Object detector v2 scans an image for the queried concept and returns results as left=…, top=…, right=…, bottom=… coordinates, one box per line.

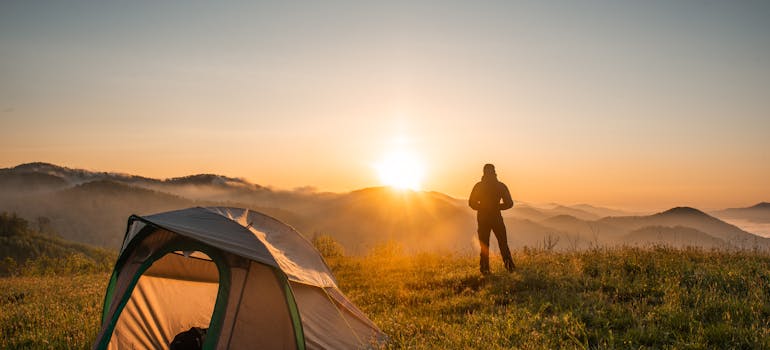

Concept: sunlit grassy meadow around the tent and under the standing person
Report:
left=0, top=248, right=770, bottom=349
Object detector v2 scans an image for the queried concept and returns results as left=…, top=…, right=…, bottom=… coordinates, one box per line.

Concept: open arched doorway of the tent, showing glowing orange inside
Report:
left=109, top=251, right=220, bottom=349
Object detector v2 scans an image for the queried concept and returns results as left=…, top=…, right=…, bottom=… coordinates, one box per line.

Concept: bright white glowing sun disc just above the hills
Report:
left=374, top=151, right=425, bottom=191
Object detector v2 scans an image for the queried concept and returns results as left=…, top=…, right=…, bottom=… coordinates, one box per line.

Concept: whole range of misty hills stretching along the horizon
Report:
left=0, top=163, right=770, bottom=254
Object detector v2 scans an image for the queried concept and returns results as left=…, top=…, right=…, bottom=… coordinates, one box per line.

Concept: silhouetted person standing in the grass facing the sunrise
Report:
left=468, top=164, right=515, bottom=274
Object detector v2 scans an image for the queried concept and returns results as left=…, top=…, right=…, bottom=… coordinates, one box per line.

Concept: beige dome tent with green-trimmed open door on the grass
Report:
left=94, top=207, right=385, bottom=349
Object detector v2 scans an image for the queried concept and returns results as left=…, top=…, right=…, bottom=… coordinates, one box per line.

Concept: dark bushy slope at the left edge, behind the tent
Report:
left=0, top=212, right=116, bottom=276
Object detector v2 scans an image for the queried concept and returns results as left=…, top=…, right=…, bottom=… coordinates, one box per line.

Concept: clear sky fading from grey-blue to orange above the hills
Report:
left=0, top=0, right=770, bottom=209
